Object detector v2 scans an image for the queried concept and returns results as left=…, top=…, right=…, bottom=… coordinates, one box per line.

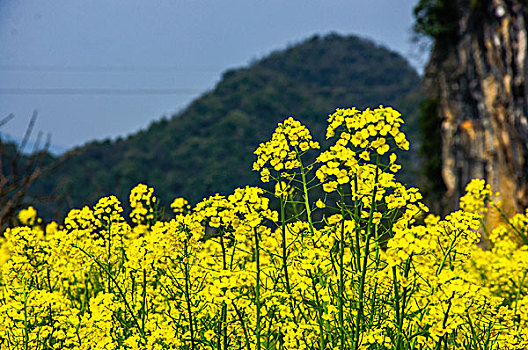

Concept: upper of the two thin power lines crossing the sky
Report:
left=0, top=65, right=224, bottom=73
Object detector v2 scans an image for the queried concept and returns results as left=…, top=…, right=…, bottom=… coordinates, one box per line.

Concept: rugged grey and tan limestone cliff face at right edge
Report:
left=424, top=0, right=528, bottom=213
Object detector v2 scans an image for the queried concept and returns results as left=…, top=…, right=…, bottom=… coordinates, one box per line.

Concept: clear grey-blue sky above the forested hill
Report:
left=0, top=0, right=426, bottom=150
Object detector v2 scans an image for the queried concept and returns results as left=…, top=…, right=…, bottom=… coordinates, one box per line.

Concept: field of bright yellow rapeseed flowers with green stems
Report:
left=0, top=106, right=528, bottom=350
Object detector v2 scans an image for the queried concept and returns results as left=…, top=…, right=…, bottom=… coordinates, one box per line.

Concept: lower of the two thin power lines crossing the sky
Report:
left=0, top=88, right=204, bottom=96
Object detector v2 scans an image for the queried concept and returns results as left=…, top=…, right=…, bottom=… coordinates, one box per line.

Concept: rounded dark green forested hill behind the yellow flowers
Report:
left=34, top=34, right=420, bottom=216
